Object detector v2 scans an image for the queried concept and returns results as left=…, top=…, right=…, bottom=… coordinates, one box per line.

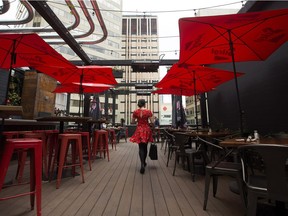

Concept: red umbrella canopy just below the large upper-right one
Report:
left=156, top=64, right=243, bottom=92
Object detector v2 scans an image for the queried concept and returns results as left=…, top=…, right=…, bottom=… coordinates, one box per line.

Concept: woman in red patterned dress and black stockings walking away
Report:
left=130, top=99, right=154, bottom=174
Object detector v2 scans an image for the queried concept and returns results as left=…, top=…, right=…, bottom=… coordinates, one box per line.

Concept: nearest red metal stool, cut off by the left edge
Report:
left=0, top=138, right=42, bottom=216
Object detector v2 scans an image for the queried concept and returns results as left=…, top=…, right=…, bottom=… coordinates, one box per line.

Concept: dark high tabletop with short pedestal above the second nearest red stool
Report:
left=36, top=116, right=91, bottom=133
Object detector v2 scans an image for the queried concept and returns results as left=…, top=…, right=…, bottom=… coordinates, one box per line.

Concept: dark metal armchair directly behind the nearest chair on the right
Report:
left=198, top=137, right=246, bottom=210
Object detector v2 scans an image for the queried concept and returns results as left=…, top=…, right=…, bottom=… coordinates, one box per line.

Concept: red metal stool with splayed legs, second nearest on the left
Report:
left=50, top=134, right=85, bottom=189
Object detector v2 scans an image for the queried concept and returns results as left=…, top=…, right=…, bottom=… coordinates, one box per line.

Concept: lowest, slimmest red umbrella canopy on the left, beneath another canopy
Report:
left=53, top=83, right=114, bottom=94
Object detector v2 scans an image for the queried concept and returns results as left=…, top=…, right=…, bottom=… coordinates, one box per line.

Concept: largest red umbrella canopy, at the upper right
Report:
left=179, top=9, right=288, bottom=65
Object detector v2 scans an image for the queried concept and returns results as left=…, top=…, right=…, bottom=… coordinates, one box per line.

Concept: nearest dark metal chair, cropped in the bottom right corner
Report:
left=239, top=144, right=288, bottom=216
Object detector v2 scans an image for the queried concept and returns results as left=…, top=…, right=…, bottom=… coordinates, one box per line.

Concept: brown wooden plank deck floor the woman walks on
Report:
left=0, top=140, right=244, bottom=216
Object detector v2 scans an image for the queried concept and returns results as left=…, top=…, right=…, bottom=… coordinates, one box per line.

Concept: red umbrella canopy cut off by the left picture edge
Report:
left=0, top=33, right=75, bottom=69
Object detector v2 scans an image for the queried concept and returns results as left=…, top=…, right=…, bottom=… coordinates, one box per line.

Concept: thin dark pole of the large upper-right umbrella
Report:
left=228, top=30, right=243, bottom=134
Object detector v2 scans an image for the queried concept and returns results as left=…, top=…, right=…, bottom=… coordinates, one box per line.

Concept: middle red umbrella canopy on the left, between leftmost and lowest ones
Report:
left=36, top=65, right=117, bottom=85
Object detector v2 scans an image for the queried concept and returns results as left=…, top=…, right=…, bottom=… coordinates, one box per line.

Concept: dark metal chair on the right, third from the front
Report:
left=173, top=133, right=206, bottom=182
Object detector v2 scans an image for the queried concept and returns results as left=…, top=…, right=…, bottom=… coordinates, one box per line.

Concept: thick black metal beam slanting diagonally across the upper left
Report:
left=28, top=0, right=92, bottom=65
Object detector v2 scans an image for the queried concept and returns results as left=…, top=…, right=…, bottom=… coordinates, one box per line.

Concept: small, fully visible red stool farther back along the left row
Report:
left=92, top=130, right=110, bottom=161
